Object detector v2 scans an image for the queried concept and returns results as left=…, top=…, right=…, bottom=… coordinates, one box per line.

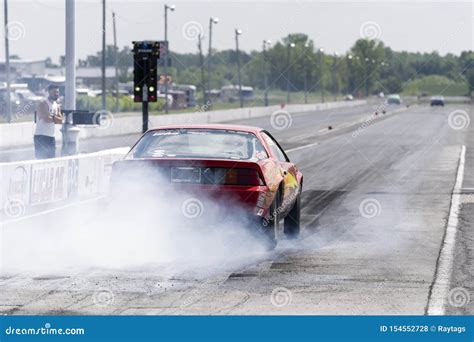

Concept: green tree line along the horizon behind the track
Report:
left=79, top=33, right=474, bottom=96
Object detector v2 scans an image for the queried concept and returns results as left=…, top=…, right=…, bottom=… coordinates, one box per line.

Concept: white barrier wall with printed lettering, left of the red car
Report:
left=0, top=147, right=129, bottom=219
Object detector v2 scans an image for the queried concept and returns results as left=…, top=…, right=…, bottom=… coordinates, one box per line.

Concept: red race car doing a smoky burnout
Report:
left=112, top=124, right=303, bottom=249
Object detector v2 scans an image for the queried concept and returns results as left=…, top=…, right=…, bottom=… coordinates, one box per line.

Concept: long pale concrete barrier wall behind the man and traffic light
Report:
left=0, top=100, right=367, bottom=148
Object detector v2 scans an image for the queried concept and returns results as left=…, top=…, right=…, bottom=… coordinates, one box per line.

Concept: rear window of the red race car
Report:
left=128, top=129, right=268, bottom=160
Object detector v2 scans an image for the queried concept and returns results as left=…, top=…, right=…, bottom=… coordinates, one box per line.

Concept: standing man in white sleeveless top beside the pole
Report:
left=34, top=84, right=63, bottom=159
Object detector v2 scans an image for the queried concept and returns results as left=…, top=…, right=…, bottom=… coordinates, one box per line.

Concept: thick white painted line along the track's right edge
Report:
left=426, top=145, right=466, bottom=315
